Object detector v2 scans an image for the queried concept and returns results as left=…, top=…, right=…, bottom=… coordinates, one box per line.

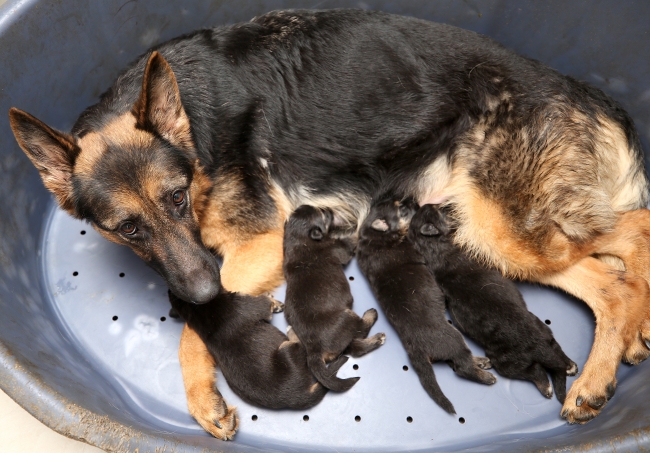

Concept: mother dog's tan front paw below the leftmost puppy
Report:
left=188, top=388, right=239, bottom=440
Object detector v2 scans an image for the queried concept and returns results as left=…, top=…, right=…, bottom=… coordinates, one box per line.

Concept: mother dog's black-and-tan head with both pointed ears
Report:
left=9, top=52, right=220, bottom=303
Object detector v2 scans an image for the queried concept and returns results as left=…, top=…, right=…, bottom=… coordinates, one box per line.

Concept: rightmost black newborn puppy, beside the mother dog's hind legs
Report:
left=409, top=205, right=578, bottom=403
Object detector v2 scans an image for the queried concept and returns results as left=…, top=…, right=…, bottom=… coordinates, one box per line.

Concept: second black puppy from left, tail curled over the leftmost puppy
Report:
left=283, top=205, right=386, bottom=392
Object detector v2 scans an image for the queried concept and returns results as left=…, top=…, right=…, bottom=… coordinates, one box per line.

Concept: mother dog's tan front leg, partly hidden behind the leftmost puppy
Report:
left=179, top=230, right=282, bottom=440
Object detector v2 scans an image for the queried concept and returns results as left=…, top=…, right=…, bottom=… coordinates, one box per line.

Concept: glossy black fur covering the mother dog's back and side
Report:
left=72, top=9, right=643, bottom=228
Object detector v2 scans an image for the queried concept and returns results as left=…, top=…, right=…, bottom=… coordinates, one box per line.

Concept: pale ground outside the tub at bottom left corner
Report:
left=0, top=386, right=104, bottom=453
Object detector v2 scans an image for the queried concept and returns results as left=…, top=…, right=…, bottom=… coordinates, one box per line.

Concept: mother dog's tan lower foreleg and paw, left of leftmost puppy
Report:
left=178, top=325, right=239, bottom=440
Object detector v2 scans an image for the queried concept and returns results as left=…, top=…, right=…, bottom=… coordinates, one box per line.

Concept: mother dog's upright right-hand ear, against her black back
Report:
left=133, top=51, right=194, bottom=151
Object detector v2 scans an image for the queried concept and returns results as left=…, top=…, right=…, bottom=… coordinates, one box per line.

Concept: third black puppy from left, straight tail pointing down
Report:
left=357, top=200, right=496, bottom=414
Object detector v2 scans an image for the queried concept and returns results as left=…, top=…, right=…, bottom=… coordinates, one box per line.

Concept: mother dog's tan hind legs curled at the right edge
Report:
left=537, top=257, right=650, bottom=423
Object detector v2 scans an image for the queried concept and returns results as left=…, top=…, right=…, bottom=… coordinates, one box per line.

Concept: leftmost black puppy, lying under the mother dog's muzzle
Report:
left=169, top=288, right=347, bottom=409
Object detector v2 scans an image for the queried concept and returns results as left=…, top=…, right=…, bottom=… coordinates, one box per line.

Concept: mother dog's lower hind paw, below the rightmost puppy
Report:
left=560, top=376, right=616, bottom=424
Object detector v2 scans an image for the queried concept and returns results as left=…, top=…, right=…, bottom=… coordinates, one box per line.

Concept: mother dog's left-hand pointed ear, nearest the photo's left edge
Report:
left=9, top=107, right=79, bottom=217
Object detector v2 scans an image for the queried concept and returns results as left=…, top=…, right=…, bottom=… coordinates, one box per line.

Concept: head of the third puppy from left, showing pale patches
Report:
left=359, top=198, right=418, bottom=237
